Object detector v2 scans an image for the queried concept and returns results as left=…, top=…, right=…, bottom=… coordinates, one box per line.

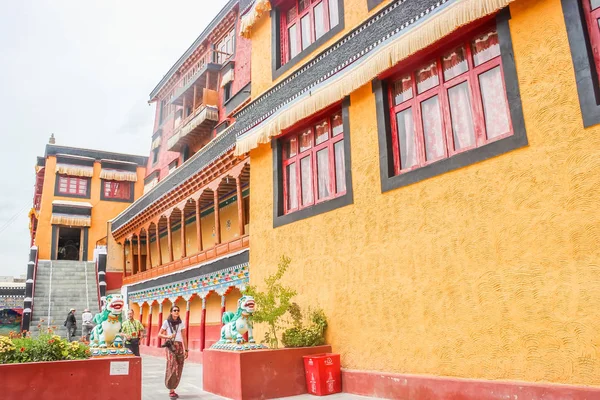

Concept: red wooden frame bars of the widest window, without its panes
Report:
left=388, top=24, right=514, bottom=175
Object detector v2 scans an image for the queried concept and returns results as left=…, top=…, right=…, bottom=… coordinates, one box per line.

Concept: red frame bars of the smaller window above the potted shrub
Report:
left=280, top=110, right=347, bottom=214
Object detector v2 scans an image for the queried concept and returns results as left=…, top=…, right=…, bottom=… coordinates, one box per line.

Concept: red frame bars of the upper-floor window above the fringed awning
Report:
left=280, top=0, right=340, bottom=65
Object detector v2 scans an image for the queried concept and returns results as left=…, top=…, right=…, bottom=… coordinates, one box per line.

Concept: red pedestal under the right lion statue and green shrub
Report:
left=202, top=346, right=331, bottom=400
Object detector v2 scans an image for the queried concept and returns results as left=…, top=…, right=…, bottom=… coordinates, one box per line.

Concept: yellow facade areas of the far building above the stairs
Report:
left=35, top=156, right=146, bottom=262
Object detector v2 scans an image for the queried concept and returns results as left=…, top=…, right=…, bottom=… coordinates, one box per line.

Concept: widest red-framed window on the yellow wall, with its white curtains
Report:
left=389, top=27, right=510, bottom=174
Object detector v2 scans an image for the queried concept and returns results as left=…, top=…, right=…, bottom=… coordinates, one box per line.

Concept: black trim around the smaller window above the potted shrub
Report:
left=271, top=97, right=354, bottom=228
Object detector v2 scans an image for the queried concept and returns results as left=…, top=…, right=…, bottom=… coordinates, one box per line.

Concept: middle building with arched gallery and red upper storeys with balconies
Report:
left=108, top=0, right=251, bottom=358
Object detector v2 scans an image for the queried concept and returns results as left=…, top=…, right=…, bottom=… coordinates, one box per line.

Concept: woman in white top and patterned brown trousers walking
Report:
left=158, top=305, right=188, bottom=399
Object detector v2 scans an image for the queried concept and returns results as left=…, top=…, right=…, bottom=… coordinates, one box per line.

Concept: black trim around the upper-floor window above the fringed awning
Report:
left=271, top=0, right=345, bottom=80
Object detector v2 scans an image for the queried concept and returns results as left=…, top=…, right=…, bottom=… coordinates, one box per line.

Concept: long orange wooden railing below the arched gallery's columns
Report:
left=123, top=235, right=250, bottom=285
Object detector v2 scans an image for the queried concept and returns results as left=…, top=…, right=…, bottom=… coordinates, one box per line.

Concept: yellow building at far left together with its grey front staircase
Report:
left=23, top=137, right=147, bottom=334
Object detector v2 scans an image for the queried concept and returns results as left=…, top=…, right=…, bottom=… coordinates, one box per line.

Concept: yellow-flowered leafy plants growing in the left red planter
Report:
left=0, top=329, right=91, bottom=364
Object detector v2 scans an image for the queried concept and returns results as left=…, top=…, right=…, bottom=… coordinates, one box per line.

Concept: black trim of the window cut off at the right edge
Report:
left=561, top=0, right=600, bottom=128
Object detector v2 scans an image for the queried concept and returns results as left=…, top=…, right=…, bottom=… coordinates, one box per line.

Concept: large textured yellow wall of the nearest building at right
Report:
left=250, top=0, right=600, bottom=385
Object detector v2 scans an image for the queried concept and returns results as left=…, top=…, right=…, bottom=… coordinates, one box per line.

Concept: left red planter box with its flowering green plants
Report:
left=0, top=325, right=142, bottom=400
